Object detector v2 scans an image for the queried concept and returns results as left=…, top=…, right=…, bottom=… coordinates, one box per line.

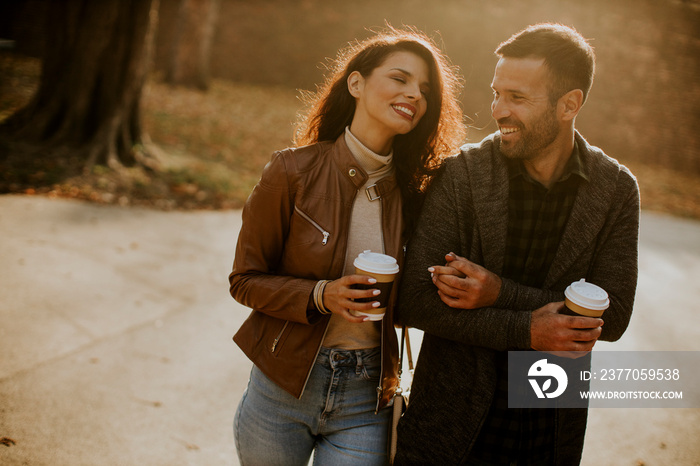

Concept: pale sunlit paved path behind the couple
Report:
left=0, top=195, right=700, bottom=466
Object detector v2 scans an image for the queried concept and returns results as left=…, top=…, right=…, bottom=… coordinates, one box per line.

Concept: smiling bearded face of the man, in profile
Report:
left=491, top=58, right=560, bottom=160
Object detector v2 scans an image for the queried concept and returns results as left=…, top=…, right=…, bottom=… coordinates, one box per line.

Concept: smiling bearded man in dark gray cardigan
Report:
left=396, top=24, right=639, bottom=466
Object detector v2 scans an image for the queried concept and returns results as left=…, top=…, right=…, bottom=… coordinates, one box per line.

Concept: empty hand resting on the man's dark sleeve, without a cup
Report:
left=428, top=253, right=501, bottom=309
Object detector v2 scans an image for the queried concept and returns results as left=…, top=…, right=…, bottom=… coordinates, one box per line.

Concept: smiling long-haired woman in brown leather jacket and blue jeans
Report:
left=229, top=29, right=464, bottom=466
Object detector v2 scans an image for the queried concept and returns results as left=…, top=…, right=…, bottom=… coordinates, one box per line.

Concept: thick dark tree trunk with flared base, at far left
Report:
left=2, top=0, right=158, bottom=173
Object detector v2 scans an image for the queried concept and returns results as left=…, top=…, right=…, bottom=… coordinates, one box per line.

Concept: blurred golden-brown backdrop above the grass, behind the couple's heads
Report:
left=155, top=0, right=700, bottom=174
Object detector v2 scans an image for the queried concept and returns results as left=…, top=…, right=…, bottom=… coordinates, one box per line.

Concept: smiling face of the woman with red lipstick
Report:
left=348, top=51, right=430, bottom=154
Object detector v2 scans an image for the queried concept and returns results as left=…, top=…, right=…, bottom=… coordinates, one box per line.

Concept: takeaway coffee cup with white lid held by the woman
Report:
left=350, top=250, right=399, bottom=320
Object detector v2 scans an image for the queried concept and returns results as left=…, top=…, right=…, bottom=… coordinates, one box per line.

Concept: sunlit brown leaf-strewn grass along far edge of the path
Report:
left=0, top=55, right=700, bottom=219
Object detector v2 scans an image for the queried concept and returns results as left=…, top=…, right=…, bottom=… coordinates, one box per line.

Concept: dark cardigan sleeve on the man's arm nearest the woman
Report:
left=398, top=157, right=530, bottom=350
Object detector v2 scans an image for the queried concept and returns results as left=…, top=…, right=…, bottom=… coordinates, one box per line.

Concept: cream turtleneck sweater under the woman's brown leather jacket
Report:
left=323, top=127, right=393, bottom=349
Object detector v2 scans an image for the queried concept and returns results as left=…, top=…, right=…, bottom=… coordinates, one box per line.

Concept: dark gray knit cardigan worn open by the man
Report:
left=397, top=133, right=639, bottom=465
